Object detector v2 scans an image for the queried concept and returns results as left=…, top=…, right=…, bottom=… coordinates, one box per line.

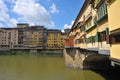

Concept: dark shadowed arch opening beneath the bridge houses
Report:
left=83, top=54, right=110, bottom=69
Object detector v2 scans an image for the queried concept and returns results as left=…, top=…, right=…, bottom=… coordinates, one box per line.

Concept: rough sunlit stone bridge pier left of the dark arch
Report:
left=64, top=48, right=85, bottom=69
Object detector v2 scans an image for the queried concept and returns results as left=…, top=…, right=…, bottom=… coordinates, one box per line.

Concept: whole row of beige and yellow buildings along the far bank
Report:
left=0, top=23, right=64, bottom=50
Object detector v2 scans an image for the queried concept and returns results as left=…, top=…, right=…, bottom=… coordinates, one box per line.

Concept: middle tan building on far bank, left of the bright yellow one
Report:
left=23, top=26, right=45, bottom=49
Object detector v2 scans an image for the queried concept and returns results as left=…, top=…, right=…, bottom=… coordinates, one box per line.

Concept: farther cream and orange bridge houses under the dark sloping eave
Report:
left=72, top=0, right=98, bottom=51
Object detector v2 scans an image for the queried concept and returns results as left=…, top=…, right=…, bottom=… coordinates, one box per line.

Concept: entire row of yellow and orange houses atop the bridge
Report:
left=65, top=0, right=120, bottom=66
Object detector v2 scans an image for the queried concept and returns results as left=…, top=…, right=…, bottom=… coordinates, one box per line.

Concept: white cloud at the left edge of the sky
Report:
left=0, top=0, right=18, bottom=27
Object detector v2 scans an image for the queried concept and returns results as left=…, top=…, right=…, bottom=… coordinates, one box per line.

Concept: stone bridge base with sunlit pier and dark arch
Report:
left=64, top=47, right=110, bottom=69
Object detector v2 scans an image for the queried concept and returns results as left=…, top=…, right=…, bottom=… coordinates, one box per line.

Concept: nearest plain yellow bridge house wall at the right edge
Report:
left=108, top=0, right=120, bottom=66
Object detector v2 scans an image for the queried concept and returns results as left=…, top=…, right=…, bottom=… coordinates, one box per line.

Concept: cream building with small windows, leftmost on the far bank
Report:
left=0, top=28, right=18, bottom=48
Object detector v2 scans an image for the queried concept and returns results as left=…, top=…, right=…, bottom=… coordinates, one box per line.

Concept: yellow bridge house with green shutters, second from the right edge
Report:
left=92, top=0, right=110, bottom=55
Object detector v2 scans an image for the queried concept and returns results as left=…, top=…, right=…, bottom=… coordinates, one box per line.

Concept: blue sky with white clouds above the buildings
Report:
left=0, top=0, right=84, bottom=31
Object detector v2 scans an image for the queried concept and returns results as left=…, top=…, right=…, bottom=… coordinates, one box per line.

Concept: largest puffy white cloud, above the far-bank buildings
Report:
left=13, top=0, right=54, bottom=26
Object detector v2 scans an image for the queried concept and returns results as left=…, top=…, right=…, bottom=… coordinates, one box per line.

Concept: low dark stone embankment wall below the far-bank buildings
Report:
left=0, top=48, right=63, bottom=56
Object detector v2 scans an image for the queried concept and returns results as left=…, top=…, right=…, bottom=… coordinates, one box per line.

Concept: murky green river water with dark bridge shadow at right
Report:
left=0, top=55, right=120, bottom=80
